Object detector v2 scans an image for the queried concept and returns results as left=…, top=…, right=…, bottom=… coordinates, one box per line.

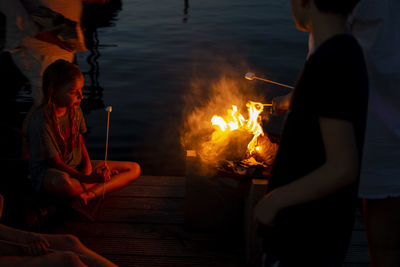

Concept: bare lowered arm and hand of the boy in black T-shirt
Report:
left=255, top=117, right=359, bottom=225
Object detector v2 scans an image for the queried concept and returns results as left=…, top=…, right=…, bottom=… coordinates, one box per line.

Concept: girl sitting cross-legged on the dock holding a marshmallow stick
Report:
left=28, top=60, right=140, bottom=211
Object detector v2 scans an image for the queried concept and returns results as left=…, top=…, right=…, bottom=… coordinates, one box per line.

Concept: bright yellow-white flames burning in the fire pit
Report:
left=211, top=101, right=264, bottom=158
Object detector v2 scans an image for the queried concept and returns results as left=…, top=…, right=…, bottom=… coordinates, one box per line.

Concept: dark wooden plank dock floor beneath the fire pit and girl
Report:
left=44, top=176, right=369, bottom=267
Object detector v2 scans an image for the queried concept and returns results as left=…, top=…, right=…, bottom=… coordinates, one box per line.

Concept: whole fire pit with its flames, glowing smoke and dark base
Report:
left=181, top=76, right=279, bottom=264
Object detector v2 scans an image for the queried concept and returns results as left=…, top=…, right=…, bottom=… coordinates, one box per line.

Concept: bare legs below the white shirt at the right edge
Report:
left=364, top=198, right=400, bottom=267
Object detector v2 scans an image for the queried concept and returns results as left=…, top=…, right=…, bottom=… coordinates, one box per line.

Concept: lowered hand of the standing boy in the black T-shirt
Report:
left=254, top=190, right=281, bottom=226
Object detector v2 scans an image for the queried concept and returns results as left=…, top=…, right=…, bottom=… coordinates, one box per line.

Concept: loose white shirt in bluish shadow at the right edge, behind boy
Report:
left=350, top=0, right=400, bottom=199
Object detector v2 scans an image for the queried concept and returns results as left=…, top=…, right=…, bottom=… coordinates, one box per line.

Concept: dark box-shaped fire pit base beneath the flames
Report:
left=184, top=150, right=276, bottom=266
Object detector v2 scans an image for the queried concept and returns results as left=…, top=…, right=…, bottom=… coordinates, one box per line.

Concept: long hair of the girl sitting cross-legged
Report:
left=41, top=59, right=83, bottom=156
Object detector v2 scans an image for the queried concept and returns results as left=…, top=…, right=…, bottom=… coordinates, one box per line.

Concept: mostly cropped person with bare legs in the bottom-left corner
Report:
left=0, top=195, right=116, bottom=267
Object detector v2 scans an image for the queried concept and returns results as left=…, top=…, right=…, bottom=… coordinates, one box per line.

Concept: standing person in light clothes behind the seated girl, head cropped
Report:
left=0, top=0, right=106, bottom=158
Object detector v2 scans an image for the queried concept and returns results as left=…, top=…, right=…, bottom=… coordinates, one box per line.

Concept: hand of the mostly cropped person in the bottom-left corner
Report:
left=18, top=232, right=50, bottom=256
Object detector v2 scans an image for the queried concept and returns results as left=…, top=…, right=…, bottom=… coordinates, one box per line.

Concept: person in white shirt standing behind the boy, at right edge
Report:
left=350, top=0, right=400, bottom=267
